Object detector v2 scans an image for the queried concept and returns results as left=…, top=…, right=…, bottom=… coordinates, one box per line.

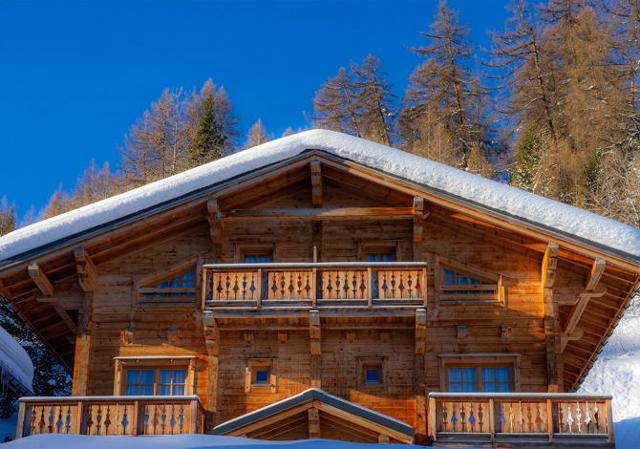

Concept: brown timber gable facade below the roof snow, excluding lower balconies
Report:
left=0, top=140, right=639, bottom=442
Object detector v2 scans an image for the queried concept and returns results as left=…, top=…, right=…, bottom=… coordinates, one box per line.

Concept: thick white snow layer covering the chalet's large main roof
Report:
left=0, top=130, right=640, bottom=264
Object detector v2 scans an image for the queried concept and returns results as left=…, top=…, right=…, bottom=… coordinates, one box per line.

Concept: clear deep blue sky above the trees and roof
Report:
left=0, top=0, right=507, bottom=221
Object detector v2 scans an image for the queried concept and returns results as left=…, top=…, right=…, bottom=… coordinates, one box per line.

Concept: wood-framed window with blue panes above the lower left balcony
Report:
left=113, top=356, right=195, bottom=396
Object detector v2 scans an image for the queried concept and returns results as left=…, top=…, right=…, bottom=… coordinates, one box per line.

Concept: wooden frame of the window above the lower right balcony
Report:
left=439, top=354, right=520, bottom=392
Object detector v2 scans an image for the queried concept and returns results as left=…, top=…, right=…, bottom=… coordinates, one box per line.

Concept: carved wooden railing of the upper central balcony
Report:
left=203, top=262, right=427, bottom=307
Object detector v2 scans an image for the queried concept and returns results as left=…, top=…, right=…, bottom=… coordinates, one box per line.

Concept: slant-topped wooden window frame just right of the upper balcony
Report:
left=434, top=258, right=507, bottom=305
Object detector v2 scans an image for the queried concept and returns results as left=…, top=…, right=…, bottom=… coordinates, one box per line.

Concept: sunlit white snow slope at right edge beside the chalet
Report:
left=580, top=300, right=640, bottom=449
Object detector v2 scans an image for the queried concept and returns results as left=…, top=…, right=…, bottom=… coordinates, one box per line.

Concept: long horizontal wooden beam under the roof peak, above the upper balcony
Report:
left=223, top=207, right=414, bottom=221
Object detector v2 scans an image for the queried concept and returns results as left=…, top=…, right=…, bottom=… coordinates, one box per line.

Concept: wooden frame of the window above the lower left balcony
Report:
left=113, top=356, right=196, bottom=396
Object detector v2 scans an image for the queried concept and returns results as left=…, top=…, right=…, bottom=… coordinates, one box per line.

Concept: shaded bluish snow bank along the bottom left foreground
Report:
left=2, top=435, right=415, bottom=449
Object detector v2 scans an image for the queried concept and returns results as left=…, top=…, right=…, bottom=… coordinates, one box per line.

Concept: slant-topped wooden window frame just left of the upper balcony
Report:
left=133, top=257, right=203, bottom=307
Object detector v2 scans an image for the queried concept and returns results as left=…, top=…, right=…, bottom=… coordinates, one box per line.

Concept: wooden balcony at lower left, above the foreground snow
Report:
left=16, top=396, right=204, bottom=438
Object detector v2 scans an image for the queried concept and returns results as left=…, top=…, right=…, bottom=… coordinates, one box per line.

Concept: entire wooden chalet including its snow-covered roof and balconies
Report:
left=0, top=130, right=640, bottom=447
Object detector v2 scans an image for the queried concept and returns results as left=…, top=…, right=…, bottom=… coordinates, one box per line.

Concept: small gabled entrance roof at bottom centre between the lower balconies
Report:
left=213, top=388, right=413, bottom=444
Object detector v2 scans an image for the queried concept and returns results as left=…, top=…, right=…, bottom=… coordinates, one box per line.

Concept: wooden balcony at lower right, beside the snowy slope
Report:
left=428, top=393, right=614, bottom=448
